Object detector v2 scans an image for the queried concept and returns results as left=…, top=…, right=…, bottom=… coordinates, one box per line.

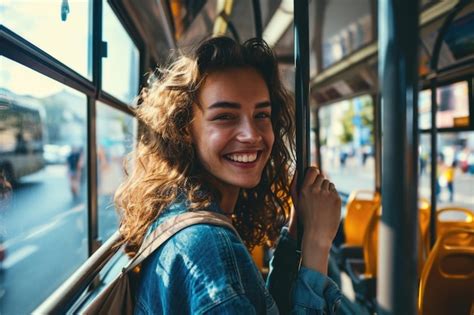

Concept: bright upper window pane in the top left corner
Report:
left=0, top=0, right=92, bottom=79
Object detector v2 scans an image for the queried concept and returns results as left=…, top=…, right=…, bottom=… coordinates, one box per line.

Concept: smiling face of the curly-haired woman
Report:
left=191, top=68, right=274, bottom=193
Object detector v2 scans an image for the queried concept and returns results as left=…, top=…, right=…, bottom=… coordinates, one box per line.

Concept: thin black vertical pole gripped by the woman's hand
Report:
left=293, top=0, right=310, bottom=250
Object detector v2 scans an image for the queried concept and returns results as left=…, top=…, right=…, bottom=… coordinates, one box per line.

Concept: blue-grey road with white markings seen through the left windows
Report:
left=0, top=165, right=116, bottom=315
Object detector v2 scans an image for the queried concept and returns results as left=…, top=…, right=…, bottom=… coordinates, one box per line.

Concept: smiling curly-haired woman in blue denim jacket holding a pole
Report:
left=116, top=37, right=341, bottom=314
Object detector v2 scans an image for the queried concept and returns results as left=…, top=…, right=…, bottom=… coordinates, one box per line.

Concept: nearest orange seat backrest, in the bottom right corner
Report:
left=418, top=229, right=474, bottom=315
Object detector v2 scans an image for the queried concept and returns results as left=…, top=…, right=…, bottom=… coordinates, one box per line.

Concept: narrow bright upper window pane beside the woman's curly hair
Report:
left=102, top=1, right=140, bottom=103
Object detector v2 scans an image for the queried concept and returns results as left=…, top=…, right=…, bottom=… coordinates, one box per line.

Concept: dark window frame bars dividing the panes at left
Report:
left=0, top=0, right=143, bottom=256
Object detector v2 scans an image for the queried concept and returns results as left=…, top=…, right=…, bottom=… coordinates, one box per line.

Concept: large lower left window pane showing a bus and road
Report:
left=0, top=57, right=88, bottom=314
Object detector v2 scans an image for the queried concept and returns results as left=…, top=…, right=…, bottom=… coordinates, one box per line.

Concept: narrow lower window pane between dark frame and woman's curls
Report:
left=97, top=102, right=137, bottom=241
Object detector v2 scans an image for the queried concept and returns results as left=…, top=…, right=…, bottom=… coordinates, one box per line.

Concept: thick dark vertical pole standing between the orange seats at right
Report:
left=377, top=0, right=419, bottom=315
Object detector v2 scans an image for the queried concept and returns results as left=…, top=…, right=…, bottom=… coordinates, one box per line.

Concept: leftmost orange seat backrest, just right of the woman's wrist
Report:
left=344, top=190, right=380, bottom=246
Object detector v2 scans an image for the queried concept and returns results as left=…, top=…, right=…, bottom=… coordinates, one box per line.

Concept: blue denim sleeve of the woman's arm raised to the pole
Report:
left=267, top=228, right=341, bottom=314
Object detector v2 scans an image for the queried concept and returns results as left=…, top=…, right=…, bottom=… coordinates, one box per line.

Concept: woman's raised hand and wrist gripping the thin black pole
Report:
left=289, top=167, right=341, bottom=274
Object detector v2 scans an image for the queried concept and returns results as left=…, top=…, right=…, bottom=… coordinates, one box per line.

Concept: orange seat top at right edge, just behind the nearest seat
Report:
left=436, top=207, right=474, bottom=245
